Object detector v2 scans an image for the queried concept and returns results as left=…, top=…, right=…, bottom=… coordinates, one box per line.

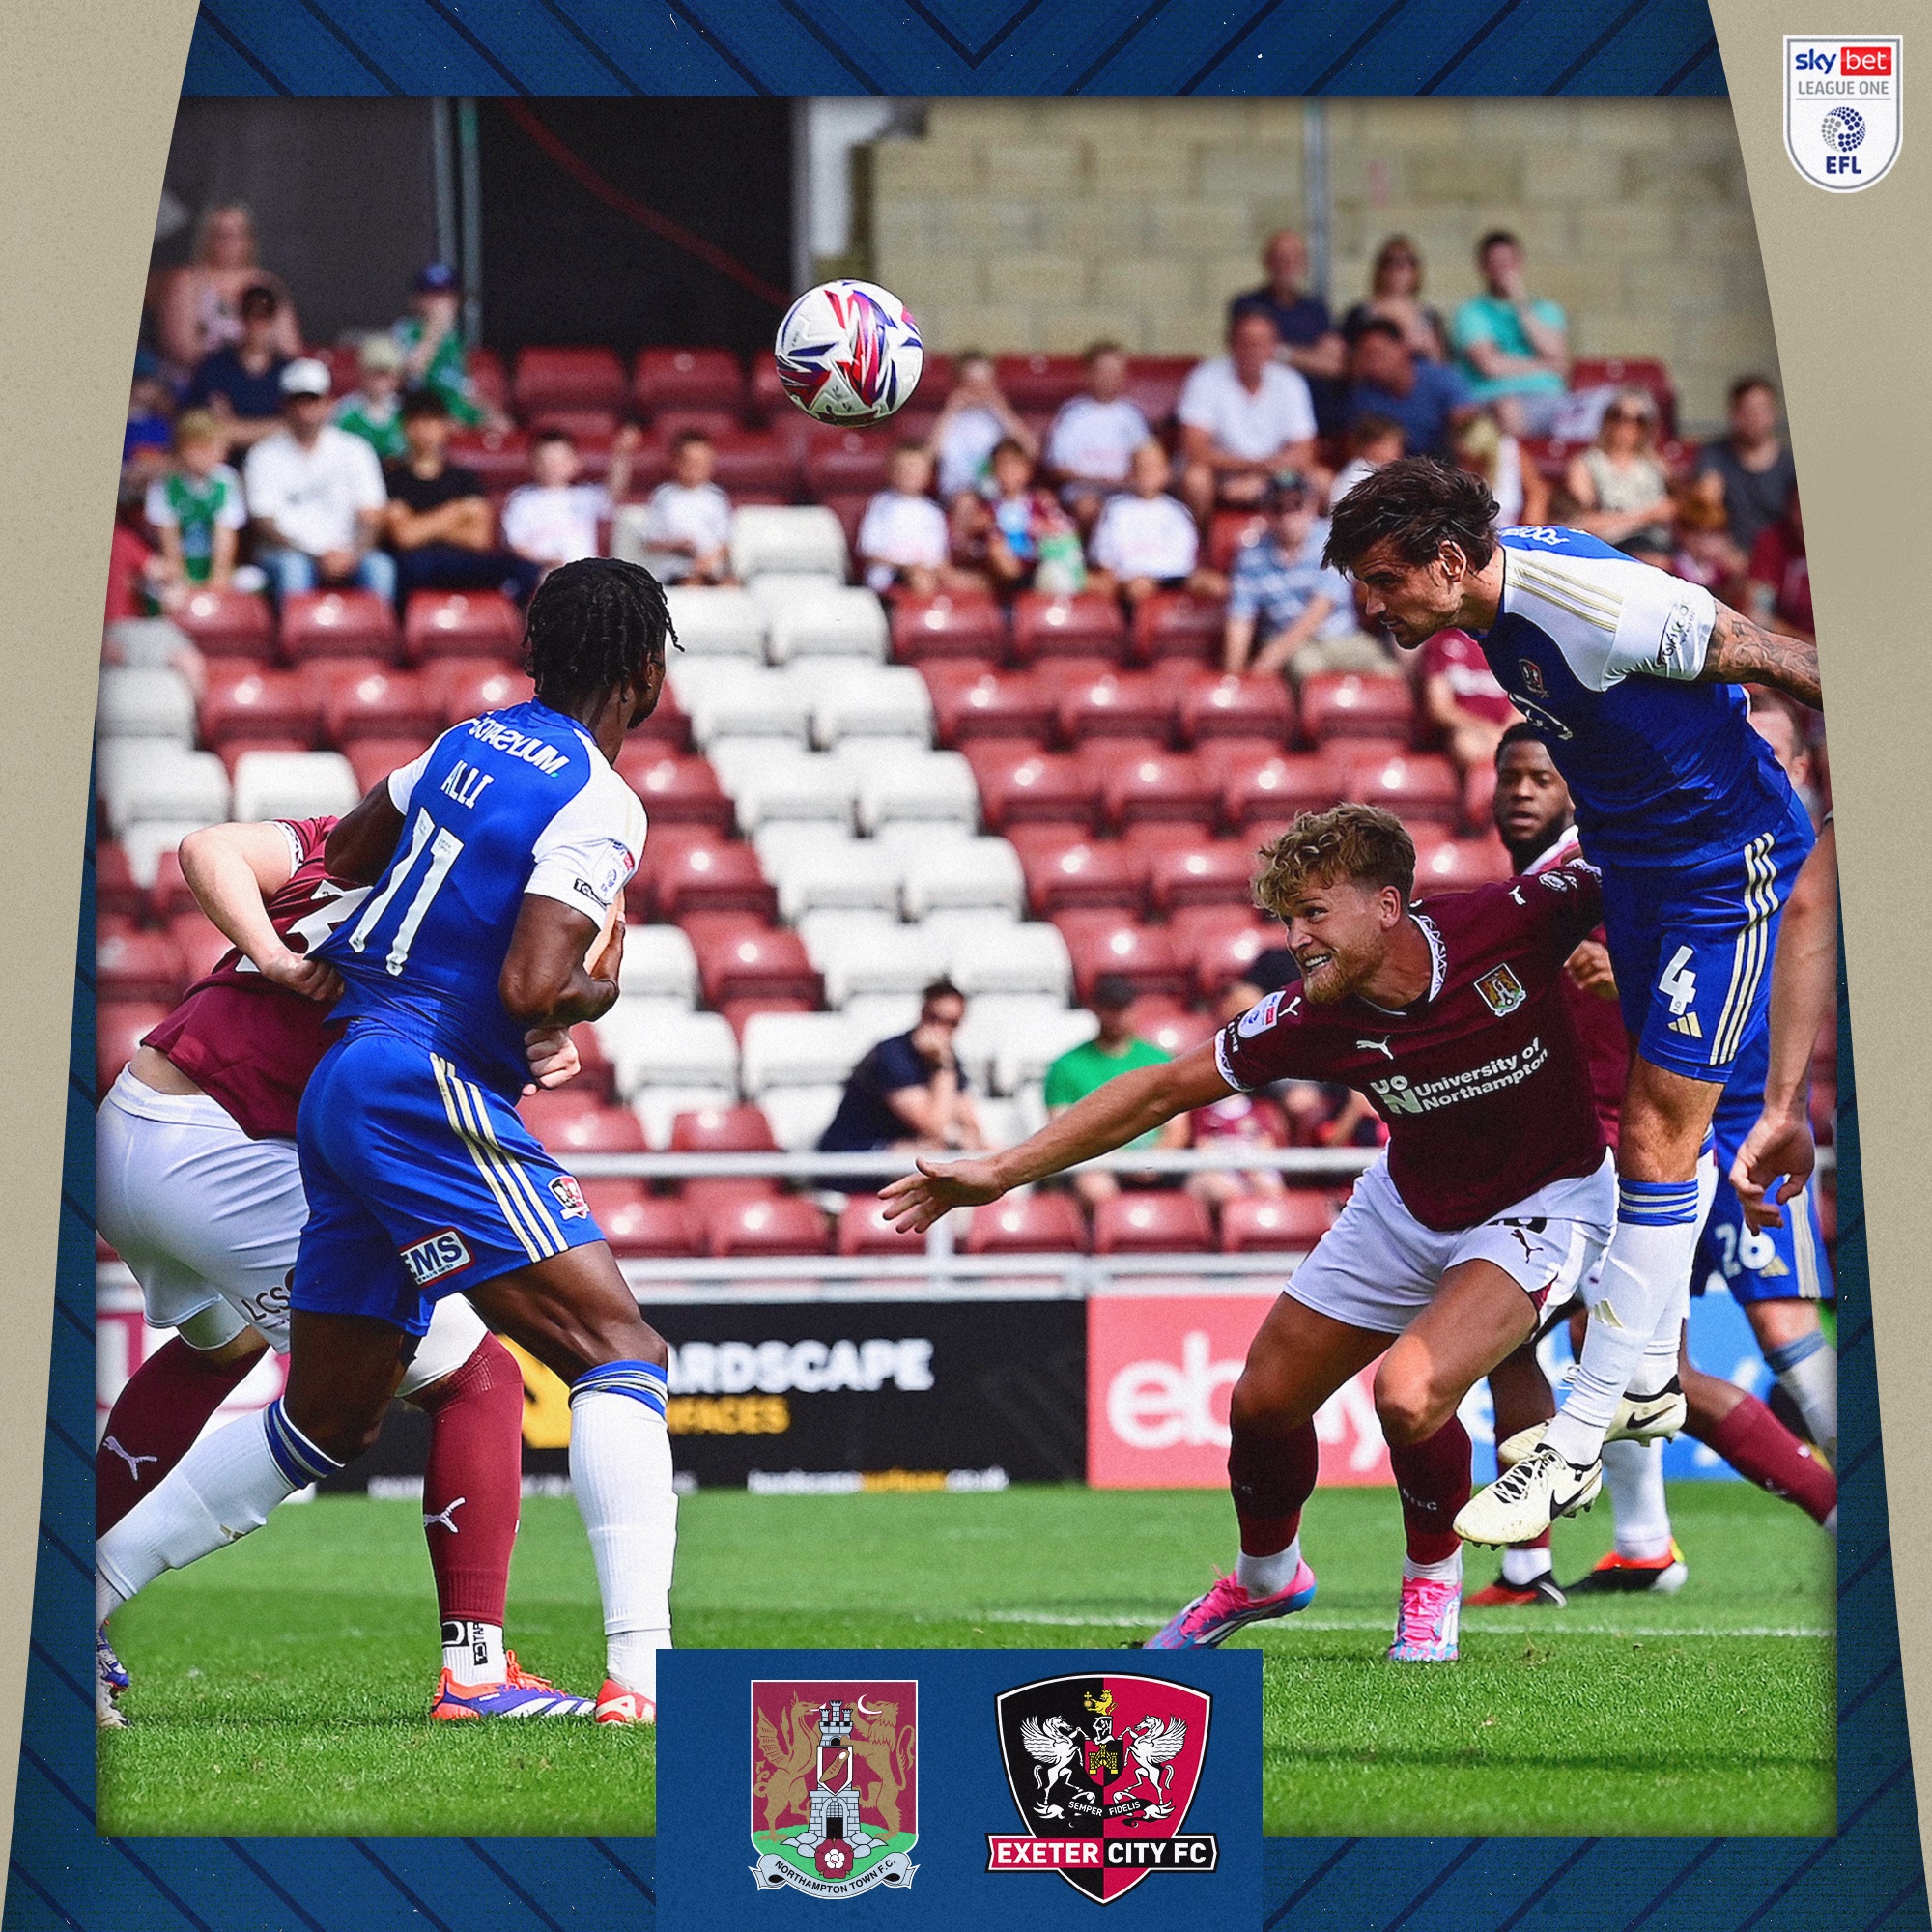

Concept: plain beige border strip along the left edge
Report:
left=0, top=0, right=195, bottom=1841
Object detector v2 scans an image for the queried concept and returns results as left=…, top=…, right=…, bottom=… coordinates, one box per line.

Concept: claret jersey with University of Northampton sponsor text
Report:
left=1215, top=862, right=1604, bottom=1231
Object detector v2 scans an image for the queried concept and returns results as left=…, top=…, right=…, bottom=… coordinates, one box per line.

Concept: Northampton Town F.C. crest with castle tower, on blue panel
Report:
left=752, top=1677, right=920, bottom=1899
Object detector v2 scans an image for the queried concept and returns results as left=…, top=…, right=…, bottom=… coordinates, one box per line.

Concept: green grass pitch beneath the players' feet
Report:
left=100, top=1482, right=1835, bottom=1837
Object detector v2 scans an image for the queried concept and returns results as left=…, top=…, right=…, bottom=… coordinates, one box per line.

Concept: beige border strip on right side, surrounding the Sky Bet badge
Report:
left=1708, top=0, right=1932, bottom=1843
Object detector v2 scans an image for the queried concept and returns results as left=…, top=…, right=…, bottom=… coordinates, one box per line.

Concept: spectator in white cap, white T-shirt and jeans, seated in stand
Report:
left=242, top=355, right=396, bottom=603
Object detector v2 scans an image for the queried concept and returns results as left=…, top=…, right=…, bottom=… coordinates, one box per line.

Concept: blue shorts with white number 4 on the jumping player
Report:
left=1604, top=802, right=1812, bottom=1084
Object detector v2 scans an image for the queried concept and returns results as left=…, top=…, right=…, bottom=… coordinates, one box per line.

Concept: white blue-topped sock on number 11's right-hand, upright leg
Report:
left=570, top=1362, right=678, bottom=1702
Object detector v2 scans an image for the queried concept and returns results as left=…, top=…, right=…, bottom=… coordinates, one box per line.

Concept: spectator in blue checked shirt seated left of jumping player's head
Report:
left=1221, top=471, right=1401, bottom=688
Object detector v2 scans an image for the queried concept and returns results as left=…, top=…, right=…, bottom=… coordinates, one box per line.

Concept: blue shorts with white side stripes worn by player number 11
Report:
left=290, top=1026, right=603, bottom=1335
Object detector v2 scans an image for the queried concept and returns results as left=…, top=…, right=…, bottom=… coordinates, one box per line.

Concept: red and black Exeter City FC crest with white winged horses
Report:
left=985, top=1671, right=1219, bottom=1905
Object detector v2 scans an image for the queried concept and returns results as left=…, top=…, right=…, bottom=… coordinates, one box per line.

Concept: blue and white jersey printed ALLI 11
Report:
left=319, top=703, right=645, bottom=1095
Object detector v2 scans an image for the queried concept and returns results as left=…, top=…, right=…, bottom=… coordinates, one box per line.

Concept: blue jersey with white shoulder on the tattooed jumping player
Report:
left=1478, top=526, right=1793, bottom=867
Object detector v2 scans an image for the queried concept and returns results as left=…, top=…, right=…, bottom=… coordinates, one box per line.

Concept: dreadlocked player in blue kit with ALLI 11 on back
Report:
left=97, top=558, right=678, bottom=1723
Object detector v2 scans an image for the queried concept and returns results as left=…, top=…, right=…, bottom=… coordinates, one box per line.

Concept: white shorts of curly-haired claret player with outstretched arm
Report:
left=1287, top=1153, right=1617, bottom=1335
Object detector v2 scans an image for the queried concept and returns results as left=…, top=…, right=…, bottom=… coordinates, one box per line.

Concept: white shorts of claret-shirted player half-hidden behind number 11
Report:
left=95, top=1068, right=485, bottom=1397
